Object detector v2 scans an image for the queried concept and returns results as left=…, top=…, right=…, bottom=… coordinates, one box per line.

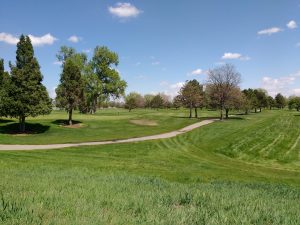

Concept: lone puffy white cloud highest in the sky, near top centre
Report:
left=108, top=2, right=142, bottom=18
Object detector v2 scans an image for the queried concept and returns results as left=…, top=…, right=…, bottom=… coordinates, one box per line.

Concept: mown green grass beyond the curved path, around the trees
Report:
left=0, top=109, right=217, bottom=144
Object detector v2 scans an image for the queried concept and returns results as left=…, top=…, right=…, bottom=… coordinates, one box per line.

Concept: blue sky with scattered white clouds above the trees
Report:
left=0, top=0, right=300, bottom=96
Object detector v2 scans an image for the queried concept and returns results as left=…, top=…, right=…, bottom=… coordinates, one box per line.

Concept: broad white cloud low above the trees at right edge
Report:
left=261, top=71, right=300, bottom=96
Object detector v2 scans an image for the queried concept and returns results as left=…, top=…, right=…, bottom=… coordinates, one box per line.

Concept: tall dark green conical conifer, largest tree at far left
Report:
left=6, top=35, right=52, bottom=132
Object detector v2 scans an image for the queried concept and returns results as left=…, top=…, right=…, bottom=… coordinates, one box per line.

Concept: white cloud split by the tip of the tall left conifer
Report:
left=0, top=33, right=57, bottom=46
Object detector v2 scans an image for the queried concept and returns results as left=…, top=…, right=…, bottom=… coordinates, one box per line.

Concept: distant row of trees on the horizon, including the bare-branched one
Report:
left=125, top=64, right=290, bottom=120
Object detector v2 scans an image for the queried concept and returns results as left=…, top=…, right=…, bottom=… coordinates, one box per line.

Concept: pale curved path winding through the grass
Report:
left=0, top=119, right=218, bottom=151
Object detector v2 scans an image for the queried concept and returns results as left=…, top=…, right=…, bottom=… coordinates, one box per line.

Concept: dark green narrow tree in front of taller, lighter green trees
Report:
left=56, top=58, right=84, bottom=125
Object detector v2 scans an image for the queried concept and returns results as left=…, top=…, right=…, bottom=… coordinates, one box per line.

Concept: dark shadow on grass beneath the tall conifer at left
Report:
left=0, top=123, right=50, bottom=134
